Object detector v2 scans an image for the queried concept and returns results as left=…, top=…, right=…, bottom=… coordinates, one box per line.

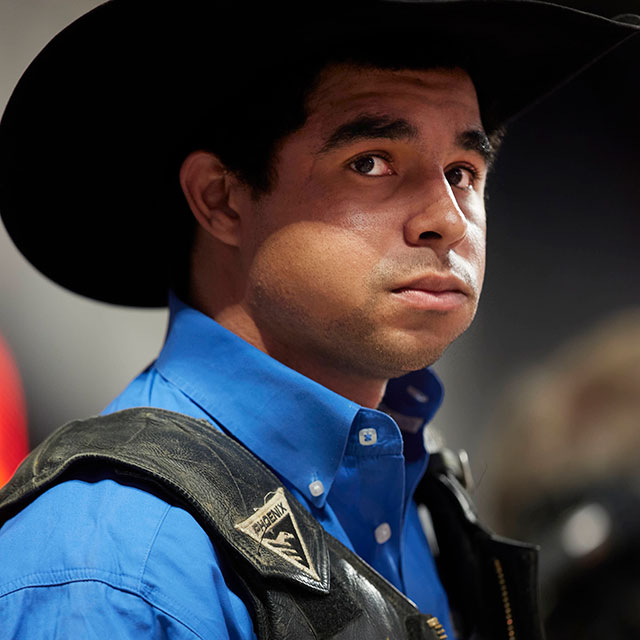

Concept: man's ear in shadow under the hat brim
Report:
left=180, top=151, right=245, bottom=246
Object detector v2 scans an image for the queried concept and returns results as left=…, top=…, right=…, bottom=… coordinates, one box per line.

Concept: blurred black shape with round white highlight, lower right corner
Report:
left=523, top=477, right=640, bottom=640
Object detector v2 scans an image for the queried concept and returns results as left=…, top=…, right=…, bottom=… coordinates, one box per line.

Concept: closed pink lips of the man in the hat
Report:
left=392, top=275, right=473, bottom=311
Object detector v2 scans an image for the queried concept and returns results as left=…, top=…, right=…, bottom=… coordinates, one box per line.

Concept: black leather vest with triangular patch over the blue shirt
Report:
left=0, top=408, right=542, bottom=640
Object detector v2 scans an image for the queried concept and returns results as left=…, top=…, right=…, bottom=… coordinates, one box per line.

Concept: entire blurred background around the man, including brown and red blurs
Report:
left=0, top=0, right=640, bottom=638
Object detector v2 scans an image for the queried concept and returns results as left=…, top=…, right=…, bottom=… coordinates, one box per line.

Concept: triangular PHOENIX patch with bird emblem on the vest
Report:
left=236, top=487, right=320, bottom=580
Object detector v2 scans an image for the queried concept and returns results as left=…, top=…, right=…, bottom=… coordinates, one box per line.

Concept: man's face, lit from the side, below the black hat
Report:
left=238, top=65, right=488, bottom=379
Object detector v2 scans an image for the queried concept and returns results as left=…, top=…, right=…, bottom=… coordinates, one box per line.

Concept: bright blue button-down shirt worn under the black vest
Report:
left=0, top=298, right=453, bottom=640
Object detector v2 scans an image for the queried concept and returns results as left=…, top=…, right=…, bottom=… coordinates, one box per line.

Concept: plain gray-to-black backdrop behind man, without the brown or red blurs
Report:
left=0, top=0, right=640, bottom=510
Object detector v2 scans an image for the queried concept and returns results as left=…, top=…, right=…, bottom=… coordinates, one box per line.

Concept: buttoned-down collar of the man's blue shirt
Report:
left=156, top=295, right=442, bottom=507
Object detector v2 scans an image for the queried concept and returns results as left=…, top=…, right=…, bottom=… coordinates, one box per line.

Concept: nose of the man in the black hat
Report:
left=404, top=177, right=469, bottom=253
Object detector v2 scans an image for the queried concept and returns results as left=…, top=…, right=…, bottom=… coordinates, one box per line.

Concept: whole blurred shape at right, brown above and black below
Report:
left=487, top=309, right=640, bottom=640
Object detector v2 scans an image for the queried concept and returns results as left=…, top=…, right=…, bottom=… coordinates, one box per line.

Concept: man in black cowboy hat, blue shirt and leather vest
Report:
left=0, top=0, right=636, bottom=638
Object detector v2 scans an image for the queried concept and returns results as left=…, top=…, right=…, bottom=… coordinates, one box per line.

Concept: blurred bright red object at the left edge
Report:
left=0, top=336, right=29, bottom=486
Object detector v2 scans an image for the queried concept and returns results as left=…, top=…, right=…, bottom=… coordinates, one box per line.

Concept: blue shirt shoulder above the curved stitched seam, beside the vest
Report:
left=0, top=477, right=255, bottom=635
